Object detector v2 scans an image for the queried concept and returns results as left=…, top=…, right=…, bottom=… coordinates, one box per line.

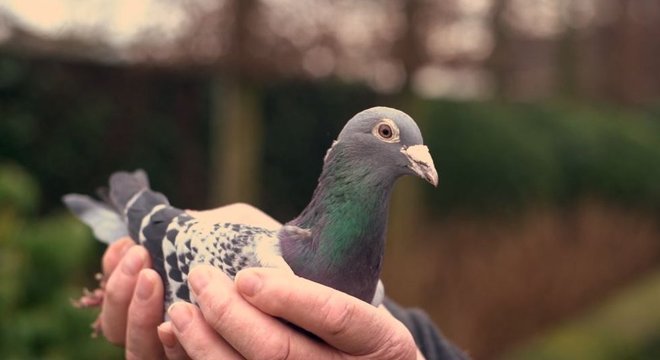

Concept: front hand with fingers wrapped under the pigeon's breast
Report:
left=161, top=265, right=423, bottom=359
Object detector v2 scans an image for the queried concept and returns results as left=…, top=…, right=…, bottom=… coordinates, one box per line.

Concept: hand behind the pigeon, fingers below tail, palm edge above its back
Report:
left=99, top=203, right=280, bottom=359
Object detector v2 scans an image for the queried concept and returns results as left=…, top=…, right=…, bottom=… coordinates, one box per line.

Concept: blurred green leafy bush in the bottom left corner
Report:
left=0, top=164, right=120, bottom=359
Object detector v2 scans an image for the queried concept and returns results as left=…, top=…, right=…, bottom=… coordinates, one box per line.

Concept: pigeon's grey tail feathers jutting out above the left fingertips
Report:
left=62, top=170, right=169, bottom=244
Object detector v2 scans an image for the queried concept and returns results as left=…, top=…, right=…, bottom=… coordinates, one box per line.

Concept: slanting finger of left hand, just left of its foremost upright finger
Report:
left=101, top=246, right=149, bottom=345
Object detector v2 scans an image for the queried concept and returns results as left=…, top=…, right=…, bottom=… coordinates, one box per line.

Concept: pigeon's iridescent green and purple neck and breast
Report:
left=281, top=148, right=395, bottom=302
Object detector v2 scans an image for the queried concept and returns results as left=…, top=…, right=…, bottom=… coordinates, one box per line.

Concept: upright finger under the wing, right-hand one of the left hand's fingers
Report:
left=126, top=269, right=163, bottom=359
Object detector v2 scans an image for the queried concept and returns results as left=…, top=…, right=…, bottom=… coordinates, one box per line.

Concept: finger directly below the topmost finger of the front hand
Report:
left=187, top=265, right=333, bottom=359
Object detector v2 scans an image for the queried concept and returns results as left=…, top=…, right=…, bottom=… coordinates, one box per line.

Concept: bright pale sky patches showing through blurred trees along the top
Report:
left=0, top=0, right=532, bottom=98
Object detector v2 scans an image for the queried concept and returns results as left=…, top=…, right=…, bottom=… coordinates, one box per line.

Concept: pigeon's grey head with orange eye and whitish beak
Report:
left=326, top=107, right=438, bottom=186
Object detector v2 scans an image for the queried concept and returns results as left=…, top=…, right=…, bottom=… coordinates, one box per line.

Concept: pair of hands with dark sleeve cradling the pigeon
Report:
left=100, top=204, right=468, bottom=360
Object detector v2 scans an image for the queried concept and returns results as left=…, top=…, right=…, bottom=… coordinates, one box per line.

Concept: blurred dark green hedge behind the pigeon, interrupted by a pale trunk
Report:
left=0, top=55, right=660, bottom=220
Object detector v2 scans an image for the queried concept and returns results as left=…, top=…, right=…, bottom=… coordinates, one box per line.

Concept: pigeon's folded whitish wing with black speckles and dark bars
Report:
left=134, top=202, right=291, bottom=308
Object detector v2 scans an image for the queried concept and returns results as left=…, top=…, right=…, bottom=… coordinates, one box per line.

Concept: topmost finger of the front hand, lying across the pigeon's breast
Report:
left=236, top=268, right=415, bottom=355
